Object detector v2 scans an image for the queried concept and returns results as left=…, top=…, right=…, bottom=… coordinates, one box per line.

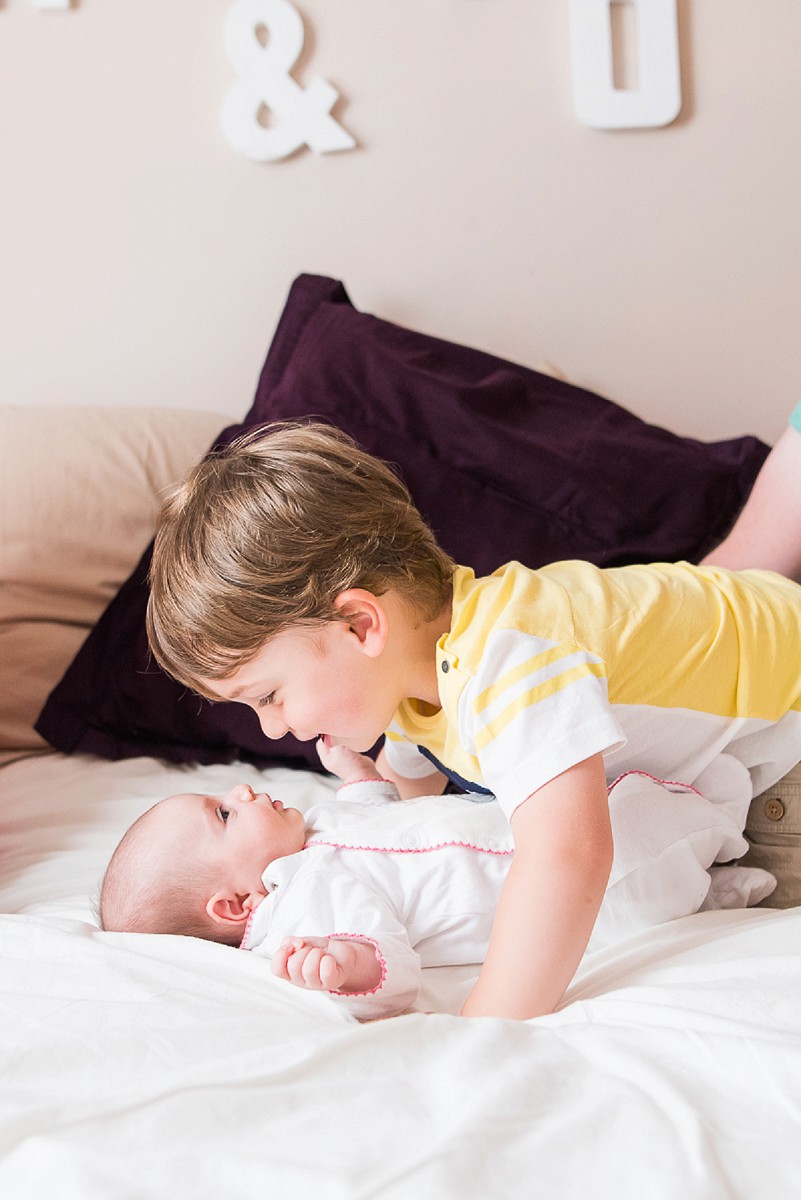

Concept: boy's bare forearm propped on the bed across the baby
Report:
left=462, top=755, right=613, bottom=1020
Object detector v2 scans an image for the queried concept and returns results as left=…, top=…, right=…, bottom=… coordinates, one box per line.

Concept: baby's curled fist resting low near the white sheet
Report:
left=271, top=937, right=381, bottom=992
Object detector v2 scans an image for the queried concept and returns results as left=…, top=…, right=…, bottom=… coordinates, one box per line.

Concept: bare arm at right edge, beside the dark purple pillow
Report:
left=703, top=425, right=801, bottom=582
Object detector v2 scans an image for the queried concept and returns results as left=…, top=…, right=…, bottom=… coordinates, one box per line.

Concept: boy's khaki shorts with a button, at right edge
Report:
left=740, top=763, right=801, bottom=908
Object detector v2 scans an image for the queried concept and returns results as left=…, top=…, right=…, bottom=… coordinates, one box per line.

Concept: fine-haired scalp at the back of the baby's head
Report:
left=97, top=804, right=235, bottom=942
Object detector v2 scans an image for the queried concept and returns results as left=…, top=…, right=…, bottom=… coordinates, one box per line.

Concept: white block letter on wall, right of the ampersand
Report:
left=570, top=0, right=681, bottom=130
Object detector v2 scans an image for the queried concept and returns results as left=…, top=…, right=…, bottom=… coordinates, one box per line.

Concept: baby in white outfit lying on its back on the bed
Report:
left=100, top=742, right=775, bottom=1019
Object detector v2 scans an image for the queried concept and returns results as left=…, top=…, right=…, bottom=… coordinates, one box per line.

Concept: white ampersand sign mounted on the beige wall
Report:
left=219, top=0, right=356, bottom=162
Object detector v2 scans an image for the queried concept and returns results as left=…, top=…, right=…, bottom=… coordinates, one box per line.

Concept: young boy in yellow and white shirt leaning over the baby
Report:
left=147, top=425, right=801, bottom=1018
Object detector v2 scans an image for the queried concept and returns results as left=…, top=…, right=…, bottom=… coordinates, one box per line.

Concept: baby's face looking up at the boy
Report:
left=153, top=784, right=306, bottom=894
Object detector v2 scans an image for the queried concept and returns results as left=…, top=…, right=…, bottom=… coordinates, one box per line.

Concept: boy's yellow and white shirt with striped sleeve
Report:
left=386, top=562, right=801, bottom=816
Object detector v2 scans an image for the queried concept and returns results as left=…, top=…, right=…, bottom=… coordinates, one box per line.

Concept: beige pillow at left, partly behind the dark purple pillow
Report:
left=0, top=406, right=226, bottom=762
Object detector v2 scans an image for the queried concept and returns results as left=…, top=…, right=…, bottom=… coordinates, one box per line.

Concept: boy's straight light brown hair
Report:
left=147, top=422, right=454, bottom=698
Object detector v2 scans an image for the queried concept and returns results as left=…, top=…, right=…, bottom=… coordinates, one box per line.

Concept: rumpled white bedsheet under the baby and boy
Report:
left=0, top=755, right=801, bottom=1200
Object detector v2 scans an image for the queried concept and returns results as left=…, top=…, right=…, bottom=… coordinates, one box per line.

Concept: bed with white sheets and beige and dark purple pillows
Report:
left=0, top=277, right=801, bottom=1200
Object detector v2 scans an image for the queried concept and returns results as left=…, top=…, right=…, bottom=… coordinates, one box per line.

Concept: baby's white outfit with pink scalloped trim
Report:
left=241, top=773, right=775, bottom=1019
